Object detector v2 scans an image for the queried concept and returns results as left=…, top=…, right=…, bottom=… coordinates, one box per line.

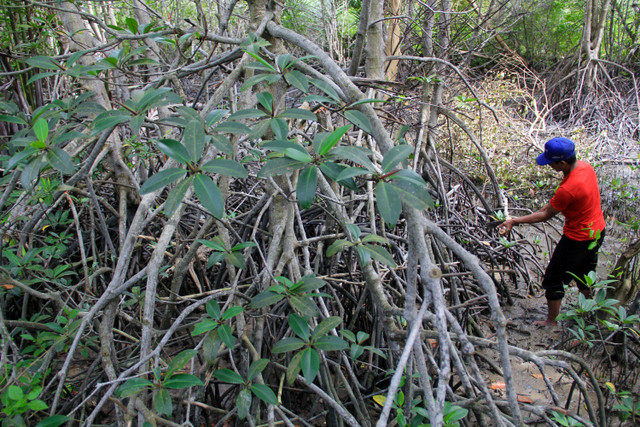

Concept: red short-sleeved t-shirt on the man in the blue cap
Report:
left=550, top=160, right=605, bottom=241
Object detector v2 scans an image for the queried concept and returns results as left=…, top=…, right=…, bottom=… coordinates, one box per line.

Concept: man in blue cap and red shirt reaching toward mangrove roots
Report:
left=499, top=137, right=605, bottom=326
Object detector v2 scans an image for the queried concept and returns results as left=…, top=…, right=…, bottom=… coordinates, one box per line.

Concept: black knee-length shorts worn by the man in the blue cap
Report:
left=542, top=230, right=604, bottom=300
